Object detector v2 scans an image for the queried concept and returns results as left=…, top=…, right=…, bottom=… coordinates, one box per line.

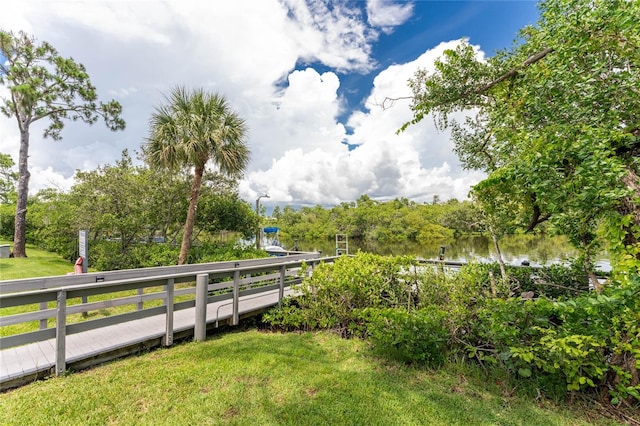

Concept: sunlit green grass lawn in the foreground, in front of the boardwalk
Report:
left=0, top=329, right=615, bottom=425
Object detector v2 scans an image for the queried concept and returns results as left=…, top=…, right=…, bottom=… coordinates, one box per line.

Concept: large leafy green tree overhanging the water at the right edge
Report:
left=401, top=0, right=640, bottom=286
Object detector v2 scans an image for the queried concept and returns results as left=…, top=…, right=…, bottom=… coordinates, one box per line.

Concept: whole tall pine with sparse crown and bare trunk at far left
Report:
left=0, top=30, right=125, bottom=257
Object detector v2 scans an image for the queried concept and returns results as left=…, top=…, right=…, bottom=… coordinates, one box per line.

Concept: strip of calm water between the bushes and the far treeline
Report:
left=283, top=235, right=609, bottom=270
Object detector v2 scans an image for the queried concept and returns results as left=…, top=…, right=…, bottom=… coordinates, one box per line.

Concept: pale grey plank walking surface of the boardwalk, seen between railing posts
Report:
left=0, top=289, right=290, bottom=390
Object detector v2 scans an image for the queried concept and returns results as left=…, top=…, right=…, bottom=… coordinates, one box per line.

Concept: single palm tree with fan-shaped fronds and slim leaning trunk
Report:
left=143, top=87, right=250, bottom=265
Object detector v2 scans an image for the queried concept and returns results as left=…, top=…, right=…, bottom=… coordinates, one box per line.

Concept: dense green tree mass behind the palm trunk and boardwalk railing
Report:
left=5, top=150, right=260, bottom=270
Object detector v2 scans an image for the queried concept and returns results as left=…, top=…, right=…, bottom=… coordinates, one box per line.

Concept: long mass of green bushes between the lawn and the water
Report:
left=265, top=253, right=640, bottom=408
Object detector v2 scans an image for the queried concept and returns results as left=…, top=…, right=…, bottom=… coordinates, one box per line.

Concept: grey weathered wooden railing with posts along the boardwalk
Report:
left=0, top=253, right=335, bottom=382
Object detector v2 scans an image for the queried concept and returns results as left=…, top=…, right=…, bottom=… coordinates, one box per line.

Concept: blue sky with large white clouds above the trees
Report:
left=0, top=0, right=538, bottom=206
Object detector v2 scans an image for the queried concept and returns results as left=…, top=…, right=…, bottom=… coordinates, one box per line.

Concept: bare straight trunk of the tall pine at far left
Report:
left=13, top=126, right=31, bottom=257
